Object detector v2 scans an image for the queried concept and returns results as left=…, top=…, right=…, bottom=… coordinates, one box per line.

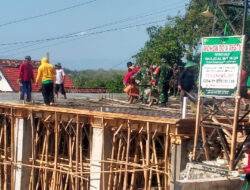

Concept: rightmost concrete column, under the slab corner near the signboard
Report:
left=170, top=140, right=188, bottom=190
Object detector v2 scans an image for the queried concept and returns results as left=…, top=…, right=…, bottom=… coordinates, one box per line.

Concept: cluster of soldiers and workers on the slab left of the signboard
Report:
left=127, top=59, right=197, bottom=107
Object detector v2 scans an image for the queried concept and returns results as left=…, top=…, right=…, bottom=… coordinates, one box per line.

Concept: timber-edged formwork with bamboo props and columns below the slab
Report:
left=0, top=103, right=194, bottom=189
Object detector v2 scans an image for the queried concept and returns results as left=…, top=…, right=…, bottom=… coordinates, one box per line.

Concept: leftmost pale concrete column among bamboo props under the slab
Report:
left=14, top=119, right=32, bottom=190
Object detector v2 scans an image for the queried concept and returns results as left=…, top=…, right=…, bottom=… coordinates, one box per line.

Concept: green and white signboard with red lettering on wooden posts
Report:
left=199, top=36, right=244, bottom=97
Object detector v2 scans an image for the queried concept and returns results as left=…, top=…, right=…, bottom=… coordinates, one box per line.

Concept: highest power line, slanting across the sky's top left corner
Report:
left=0, top=0, right=97, bottom=27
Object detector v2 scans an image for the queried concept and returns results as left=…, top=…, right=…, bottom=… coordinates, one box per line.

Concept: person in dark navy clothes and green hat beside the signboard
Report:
left=178, top=61, right=197, bottom=108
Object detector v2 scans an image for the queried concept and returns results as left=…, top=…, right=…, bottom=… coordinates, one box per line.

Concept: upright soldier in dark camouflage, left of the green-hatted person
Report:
left=158, top=59, right=171, bottom=107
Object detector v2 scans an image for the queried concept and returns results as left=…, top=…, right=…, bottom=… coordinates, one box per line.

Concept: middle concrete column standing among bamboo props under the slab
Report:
left=90, top=119, right=112, bottom=190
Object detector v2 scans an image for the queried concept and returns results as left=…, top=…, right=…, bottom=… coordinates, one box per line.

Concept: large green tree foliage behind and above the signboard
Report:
left=133, top=0, right=250, bottom=71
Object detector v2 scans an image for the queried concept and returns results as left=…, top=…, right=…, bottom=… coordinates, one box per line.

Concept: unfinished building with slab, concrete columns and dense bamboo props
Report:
left=0, top=95, right=249, bottom=190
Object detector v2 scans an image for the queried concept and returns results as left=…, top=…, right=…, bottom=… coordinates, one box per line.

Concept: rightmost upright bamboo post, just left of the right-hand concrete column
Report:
left=164, top=124, right=169, bottom=190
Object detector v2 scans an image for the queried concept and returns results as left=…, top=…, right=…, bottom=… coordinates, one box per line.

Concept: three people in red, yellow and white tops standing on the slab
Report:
left=18, top=56, right=66, bottom=106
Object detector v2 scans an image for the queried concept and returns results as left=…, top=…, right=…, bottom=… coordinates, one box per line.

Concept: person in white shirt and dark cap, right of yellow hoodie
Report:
left=55, top=63, right=67, bottom=99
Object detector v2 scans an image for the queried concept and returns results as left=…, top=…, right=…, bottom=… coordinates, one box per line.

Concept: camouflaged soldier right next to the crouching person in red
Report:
left=135, top=63, right=151, bottom=104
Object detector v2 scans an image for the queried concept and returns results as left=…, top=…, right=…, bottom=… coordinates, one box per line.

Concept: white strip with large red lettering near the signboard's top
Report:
left=203, top=44, right=242, bottom=52
